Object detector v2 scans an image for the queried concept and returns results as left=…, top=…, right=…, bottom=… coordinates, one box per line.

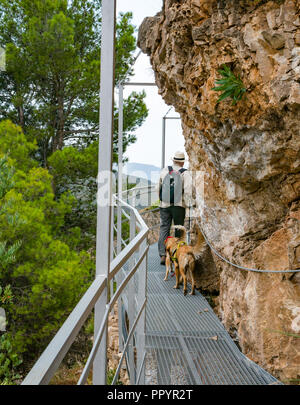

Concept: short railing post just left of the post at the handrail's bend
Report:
left=127, top=210, right=136, bottom=385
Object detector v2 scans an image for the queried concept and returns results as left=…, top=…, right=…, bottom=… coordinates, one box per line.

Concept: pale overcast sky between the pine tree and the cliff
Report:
left=116, top=0, right=187, bottom=167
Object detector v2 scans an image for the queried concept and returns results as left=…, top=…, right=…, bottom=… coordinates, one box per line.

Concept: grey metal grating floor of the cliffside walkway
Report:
left=145, top=244, right=279, bottom=385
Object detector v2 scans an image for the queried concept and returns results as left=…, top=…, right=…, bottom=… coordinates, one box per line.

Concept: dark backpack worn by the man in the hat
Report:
left=159, top=166, right=186, bottom=204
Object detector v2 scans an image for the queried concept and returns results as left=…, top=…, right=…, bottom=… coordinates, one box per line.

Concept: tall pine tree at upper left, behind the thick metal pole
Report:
left=0, top=0, right=147, bottom=167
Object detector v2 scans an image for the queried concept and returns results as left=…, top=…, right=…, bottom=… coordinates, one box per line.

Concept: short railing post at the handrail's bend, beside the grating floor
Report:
left=137, top=240, right=148, bottom=385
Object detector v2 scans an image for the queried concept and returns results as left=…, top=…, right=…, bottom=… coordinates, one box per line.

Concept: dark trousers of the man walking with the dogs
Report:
left=158, top=205, right=185, bottom=256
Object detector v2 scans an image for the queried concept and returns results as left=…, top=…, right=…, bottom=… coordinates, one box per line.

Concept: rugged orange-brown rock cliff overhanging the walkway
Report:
left=139, top=0, right=300, bottom=381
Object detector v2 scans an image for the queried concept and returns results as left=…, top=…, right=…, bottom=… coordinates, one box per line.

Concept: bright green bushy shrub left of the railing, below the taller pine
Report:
left=0, top=121, right=94, bottom=364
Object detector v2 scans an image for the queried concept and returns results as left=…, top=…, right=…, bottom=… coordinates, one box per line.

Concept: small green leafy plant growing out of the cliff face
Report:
left=212, top=65, right=246, bottom=105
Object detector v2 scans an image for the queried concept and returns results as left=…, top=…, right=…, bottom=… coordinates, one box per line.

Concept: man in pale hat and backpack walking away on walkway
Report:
left=158, top=152, right=188, bottom=264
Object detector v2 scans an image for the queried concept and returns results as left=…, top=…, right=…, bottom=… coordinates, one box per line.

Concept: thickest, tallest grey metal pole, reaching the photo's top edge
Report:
left=93, top=0, right=116, bottom=385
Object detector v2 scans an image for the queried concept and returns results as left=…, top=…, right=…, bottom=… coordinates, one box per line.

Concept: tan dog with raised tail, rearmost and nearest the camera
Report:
left=174, top=223, right=206, bottom=295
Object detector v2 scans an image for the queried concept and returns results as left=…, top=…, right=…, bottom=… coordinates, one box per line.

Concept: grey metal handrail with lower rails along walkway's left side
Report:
left=22, top=196, right=149, bottom=385
